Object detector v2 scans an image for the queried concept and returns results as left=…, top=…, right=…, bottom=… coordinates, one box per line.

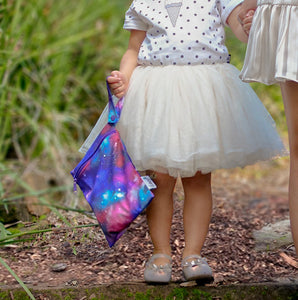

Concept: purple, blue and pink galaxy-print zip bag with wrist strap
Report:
left=71, top=79, right=153, bottom=247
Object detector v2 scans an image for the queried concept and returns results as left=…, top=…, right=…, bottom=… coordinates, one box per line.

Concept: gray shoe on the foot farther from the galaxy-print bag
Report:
left=182, top=254, right=213, bottom=281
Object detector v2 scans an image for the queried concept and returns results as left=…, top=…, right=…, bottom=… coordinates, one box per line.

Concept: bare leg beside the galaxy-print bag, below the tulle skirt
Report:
left=146, top=172, right=176, bottom=265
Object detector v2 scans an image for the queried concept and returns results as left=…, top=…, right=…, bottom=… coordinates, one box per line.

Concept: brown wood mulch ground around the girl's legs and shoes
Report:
left=0, top=159, right=298, bottom=287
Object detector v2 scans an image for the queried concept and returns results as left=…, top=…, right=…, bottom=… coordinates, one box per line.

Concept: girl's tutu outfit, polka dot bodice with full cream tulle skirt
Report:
left=81, top=0, right=286, bottom=177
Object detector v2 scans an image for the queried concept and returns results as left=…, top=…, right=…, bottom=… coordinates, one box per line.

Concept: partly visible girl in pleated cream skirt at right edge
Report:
left=239, top=0, right=298, bottom=253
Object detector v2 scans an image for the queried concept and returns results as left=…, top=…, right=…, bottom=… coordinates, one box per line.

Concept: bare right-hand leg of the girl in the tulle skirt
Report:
left=182, top=172, right=212, bottom=258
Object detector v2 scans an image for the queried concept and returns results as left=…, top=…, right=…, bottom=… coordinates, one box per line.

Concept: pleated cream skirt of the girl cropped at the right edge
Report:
left=240, top=0, right=298, bottom=84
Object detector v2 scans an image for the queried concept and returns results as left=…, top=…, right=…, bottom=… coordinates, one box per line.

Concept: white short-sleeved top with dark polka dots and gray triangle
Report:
left=124, top=0, right=242, bottom=66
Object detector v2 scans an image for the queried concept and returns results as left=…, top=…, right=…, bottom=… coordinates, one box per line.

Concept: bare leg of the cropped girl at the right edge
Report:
left=280, top=81, right=298, bottom=254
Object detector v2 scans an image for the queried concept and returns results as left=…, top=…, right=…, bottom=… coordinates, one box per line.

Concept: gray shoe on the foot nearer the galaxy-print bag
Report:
left=144, top=253, right=172, bottom=283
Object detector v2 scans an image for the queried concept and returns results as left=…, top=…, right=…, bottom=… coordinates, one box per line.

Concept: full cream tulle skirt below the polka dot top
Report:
left=83, top=64, right=286, bottom=177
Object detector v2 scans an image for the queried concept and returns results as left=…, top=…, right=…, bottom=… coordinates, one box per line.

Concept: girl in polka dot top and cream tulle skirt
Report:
left=84, top=0, right=285, bottom=283
